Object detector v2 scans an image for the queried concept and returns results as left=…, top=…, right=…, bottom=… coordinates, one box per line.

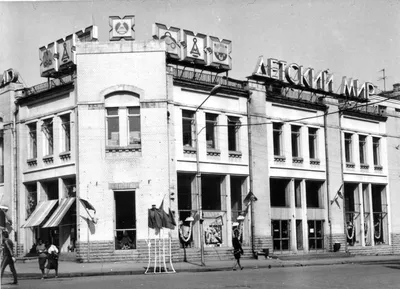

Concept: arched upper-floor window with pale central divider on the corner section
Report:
left=105, top=91, right=141, bottom=147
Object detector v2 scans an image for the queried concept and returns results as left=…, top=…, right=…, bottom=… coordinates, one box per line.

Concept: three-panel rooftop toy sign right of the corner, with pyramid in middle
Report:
left=153, top=23, right=232, bottom=71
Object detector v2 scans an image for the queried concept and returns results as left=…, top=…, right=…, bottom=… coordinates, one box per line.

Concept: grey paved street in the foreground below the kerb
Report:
left=1, top=263, right=400, bottom=289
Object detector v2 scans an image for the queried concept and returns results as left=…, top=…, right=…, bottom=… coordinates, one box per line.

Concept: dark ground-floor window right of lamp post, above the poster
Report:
left=201, top=175, right=221, bottom=211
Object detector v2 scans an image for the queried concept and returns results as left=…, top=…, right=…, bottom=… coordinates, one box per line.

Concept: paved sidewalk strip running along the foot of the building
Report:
left=5, top=255, right=400, bottom=279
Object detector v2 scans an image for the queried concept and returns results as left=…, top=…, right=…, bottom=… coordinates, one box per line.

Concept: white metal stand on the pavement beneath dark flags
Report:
left=144, top=228, right=176, bottom=274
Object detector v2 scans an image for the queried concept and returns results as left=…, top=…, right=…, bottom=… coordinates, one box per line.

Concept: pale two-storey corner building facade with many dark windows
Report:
left=0, top=29, right=400, bottom=262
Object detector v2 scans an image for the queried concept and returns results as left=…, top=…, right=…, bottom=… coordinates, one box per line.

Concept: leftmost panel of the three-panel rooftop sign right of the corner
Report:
left=153, top=23, right=181, bottom=59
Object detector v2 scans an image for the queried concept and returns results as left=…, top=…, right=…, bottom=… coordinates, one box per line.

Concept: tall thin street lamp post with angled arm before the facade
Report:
left=194, top=84, right=222, bottom=266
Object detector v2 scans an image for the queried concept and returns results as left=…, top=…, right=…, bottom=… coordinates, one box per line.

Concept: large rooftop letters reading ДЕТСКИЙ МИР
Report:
left=253, top=57, right=375, bottom=100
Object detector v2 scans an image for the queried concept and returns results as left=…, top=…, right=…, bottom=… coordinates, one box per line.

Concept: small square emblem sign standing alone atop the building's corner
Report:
left=109, top=15, right=135, bottom=41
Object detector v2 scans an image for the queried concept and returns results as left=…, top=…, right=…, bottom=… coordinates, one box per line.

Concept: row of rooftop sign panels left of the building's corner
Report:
left=39, top=25, right=98, bottom=77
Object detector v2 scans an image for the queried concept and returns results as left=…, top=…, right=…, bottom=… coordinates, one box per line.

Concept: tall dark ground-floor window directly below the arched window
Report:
left=114, top=191, right=136, bottom=250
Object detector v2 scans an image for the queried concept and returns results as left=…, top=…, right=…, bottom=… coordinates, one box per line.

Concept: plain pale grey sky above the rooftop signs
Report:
left=0, top=0, right=400, bottom=90
